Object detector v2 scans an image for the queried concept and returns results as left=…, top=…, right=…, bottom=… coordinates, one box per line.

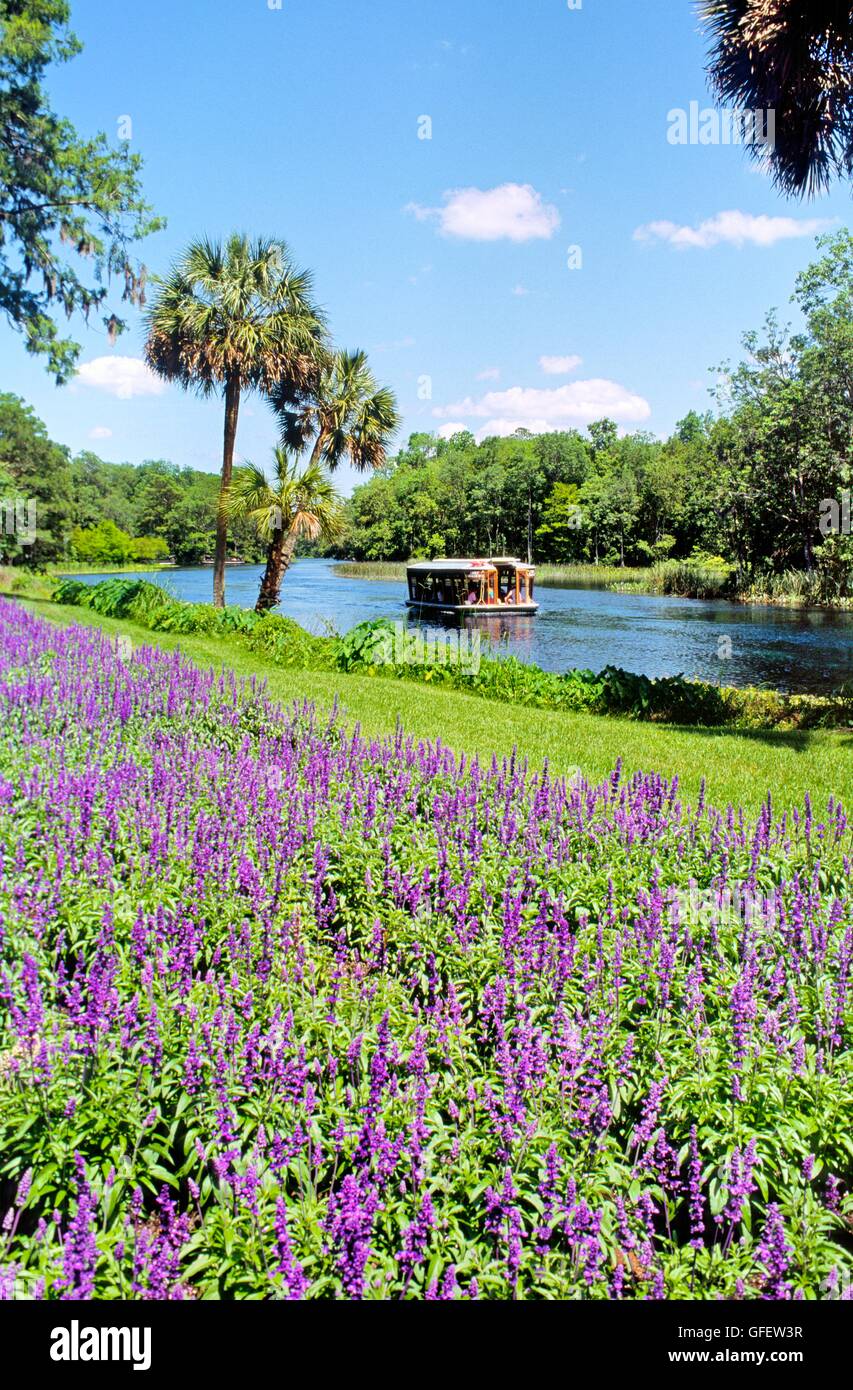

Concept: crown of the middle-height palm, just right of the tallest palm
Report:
left=271, top=352, right=400, bottom=470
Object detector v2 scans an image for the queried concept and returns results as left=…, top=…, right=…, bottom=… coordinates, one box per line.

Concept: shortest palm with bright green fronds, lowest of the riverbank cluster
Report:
left=228, top=448, right=343, bottom=613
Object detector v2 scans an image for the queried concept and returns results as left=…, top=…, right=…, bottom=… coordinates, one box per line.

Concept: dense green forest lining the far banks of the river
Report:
left=0, top=229, right=853, bottom=594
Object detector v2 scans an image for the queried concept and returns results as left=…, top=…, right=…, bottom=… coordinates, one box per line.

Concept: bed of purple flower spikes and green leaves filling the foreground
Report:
left=0, top=603, right=853, bottom=1298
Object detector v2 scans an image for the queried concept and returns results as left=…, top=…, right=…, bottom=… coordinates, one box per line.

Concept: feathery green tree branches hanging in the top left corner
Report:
left=0, top=0, right=164, bottom=382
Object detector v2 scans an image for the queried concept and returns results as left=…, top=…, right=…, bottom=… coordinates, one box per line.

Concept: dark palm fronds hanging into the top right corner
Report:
left=699, top=0, right=853, bottom=196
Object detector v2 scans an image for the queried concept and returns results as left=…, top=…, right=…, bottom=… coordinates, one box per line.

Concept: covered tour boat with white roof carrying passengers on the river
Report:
left=406, top=555, right=539, bottom=613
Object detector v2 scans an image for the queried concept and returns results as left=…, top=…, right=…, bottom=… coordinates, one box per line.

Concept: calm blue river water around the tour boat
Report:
left=81, top=560, right=853, bottom=691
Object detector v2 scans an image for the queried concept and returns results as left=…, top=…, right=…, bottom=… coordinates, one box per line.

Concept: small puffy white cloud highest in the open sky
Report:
left=404, top=183, right=560, bottom=242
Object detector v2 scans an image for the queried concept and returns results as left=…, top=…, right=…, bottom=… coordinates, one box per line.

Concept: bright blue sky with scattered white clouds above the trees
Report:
left=0, top=0, right=850, bottom=489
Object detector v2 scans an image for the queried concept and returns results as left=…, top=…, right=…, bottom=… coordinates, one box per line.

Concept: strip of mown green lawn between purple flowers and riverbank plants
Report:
left=21, top=602, right=853, bottom=810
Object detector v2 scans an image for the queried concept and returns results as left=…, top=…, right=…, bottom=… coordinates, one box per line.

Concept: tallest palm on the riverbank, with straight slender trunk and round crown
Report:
left=146, top=235, right=325, bottom=607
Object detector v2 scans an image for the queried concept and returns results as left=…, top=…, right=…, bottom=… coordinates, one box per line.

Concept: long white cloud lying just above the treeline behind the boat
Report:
left=432, top=377, right=652, bottom=438
